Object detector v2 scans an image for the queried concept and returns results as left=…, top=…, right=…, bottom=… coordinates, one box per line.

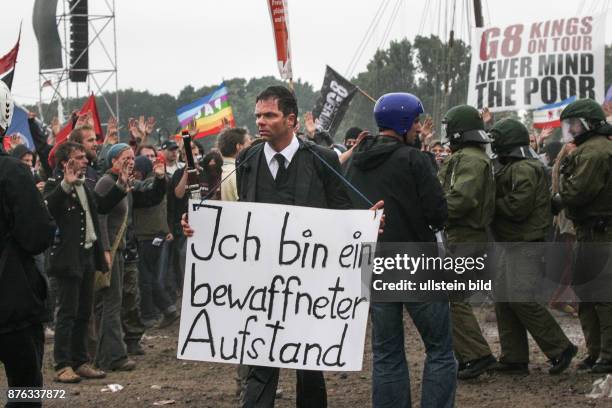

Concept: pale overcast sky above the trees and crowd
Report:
left=0, top=0, right=612, bottom=104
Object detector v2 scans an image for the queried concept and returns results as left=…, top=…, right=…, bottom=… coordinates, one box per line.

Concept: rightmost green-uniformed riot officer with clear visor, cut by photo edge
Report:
left=553, top=99, right=612, bottom=373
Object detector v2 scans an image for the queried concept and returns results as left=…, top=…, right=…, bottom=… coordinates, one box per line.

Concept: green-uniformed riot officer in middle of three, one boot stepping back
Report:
left=491, top=119, right=573, bottom=365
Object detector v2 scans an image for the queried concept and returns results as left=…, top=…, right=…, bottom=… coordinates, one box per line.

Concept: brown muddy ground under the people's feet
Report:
left=0, top=308, right=612, bottom=408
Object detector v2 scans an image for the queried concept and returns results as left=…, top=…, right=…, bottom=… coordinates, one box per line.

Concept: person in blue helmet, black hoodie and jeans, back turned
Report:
left=348, top=93, right=457, bottom=408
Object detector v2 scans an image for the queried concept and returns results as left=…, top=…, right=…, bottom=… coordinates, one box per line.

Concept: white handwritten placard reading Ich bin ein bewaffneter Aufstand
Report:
left=177, top=201, right=382, bottom=371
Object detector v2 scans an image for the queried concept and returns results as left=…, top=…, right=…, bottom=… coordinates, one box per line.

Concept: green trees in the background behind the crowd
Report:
left=29, top=35, right=612, bottom=148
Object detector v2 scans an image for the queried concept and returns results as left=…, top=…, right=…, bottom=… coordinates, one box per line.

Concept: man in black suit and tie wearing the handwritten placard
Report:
left=236, top=86, right=382, bottom=408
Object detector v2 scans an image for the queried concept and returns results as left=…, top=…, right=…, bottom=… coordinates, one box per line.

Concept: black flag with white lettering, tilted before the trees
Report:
left=312, top=66, right=357, bottom=138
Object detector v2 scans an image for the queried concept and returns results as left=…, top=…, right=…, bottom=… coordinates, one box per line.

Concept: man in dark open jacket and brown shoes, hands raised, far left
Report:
left=45, top=142, right=129, bottom=383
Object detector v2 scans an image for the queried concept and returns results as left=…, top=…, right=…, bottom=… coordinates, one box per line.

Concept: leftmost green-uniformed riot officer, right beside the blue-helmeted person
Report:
left=438, top=105, right=495, bottom=364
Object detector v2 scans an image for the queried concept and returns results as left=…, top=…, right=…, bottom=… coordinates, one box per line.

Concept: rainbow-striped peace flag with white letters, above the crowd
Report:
left=176, top=84, right=236, bottom=139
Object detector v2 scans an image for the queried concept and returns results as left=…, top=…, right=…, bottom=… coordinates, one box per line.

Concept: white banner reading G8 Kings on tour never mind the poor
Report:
left=467, top=14, right=606, bottom=112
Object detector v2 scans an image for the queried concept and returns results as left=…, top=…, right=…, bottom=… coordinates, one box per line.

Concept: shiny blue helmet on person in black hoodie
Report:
left=374, top=92, right=425, bottom=136
